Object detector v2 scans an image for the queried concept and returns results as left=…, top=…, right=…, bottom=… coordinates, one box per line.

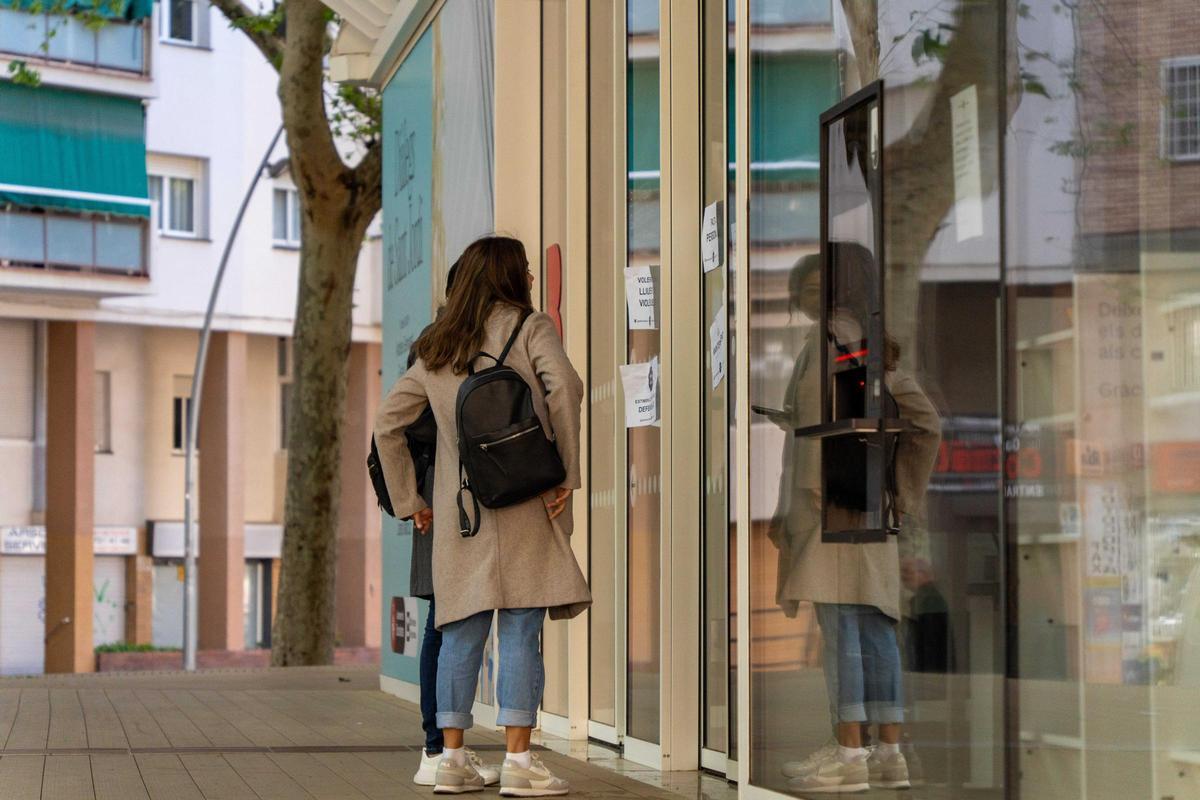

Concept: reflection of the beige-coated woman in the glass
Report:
left=770, top=243, right=941, bottom=793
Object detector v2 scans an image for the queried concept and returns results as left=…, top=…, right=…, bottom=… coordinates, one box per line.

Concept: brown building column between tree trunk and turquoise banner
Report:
left=337, top=342, right=383, bottom=648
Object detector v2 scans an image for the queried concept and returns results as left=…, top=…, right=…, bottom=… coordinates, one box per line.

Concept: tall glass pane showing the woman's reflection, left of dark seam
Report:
left=748, top=0, right=1004, bottom=798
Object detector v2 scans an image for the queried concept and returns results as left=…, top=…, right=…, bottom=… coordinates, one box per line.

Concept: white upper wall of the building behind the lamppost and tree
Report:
left=101, top=1, right=379, bottom=339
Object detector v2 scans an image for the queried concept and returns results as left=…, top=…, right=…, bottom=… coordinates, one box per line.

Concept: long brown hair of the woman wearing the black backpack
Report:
left=413, top=236, right=533, bottom=374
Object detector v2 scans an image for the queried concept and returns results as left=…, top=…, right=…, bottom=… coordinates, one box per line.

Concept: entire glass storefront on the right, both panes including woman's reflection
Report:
left=743, top=0, right=1200, bottom=800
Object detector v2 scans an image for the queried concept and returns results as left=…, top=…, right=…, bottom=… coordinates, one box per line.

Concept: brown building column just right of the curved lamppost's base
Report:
left=198, top=332, right=246, bottom=650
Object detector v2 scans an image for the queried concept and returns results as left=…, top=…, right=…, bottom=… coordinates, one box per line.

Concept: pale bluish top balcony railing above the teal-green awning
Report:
left=0, top=7, right=146, bottom=74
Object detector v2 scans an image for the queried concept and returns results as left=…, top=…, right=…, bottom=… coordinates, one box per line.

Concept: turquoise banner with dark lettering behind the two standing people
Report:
left=380, top=29, right=434, bottom=684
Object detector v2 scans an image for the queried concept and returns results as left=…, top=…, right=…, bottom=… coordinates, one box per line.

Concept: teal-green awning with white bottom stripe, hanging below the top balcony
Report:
left=0, top=82, right=150, bottom=217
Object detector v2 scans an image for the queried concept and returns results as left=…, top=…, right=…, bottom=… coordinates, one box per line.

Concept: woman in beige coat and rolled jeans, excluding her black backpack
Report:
left=374, top=236, right=592, bottom=798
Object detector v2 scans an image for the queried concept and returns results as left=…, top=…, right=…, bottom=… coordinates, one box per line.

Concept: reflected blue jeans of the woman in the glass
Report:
left=814, top=603, right=904, bottom=724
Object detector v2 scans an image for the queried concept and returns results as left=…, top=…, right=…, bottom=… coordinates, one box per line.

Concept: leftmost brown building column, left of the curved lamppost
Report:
left=46, top=321, right=96, bottom=673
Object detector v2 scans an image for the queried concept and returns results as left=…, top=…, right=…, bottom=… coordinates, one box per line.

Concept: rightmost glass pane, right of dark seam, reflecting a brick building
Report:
left=1003, top=0, right=1200, bottom=800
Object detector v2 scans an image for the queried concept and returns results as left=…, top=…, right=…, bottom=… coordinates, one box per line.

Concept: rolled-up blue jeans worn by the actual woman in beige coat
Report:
left=438, top=608, right=546, bottom=729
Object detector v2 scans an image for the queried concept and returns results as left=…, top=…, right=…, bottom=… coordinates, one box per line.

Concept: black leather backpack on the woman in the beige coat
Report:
left=455, top=311, right=566, bottom=537
